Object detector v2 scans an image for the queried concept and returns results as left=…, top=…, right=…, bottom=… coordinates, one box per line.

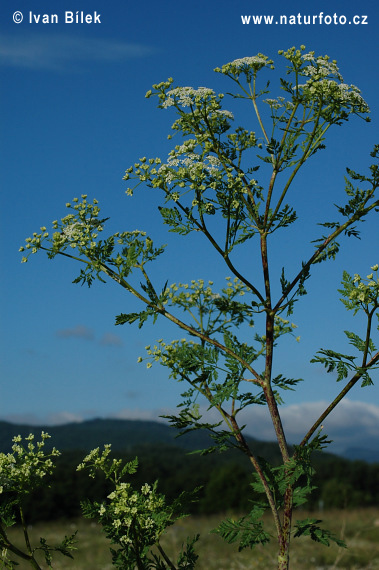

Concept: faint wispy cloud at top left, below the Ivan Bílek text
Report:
left=0, top=34, right=153, bottom=71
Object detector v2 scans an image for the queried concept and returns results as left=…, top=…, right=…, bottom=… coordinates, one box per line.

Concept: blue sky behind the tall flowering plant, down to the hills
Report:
left=0, top=0, right=379, bottom=448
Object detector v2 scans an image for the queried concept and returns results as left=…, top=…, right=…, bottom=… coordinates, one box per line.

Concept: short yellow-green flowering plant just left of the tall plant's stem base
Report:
left=78, top=445, right=197, bottom=570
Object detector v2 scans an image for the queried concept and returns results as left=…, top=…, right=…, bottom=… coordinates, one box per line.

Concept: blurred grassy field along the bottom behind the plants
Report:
left=0, top=508, right=379, bottom=570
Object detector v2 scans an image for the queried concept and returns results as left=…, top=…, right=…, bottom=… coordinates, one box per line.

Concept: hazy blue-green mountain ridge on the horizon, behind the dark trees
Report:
left=0, top=419, right=379, bottom=463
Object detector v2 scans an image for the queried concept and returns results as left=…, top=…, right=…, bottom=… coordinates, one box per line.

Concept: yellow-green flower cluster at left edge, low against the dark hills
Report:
left=0, top=432, right=60, bottom=495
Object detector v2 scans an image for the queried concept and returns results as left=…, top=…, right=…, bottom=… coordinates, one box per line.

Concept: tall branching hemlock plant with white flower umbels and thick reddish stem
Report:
left=20, top=46, right=379, bottom=570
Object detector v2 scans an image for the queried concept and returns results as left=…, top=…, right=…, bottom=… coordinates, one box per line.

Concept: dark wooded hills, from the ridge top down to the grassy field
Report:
left=0, top=412, right=379, bottom=521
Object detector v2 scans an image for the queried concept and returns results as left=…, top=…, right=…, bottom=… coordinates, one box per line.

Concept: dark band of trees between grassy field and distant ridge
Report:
left=20, top=444, right=379, bottom=523
